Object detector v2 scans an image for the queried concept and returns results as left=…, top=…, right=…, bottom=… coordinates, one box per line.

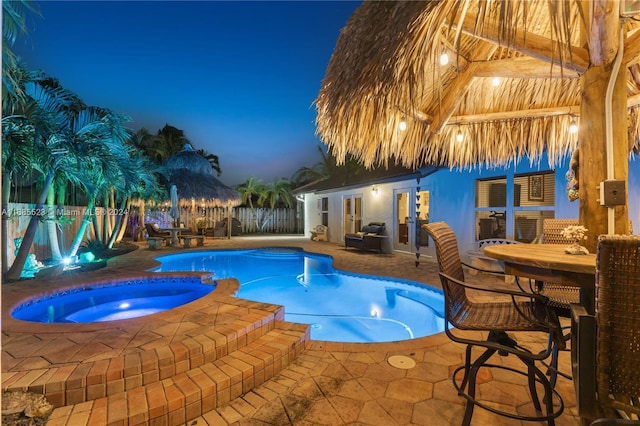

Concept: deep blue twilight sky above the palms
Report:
left=15, top=1, right=361, bottom=185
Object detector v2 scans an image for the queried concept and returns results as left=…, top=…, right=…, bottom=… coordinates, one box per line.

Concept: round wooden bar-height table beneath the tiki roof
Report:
left=484, top=244, right=596, bottom=314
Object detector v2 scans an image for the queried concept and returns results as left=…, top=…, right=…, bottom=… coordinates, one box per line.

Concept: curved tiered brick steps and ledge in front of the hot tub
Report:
left=2, top=280, right=310, bottom=426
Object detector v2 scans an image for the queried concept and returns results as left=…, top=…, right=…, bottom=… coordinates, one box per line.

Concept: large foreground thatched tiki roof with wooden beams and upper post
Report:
left=316, top=0, right=640, bottom=251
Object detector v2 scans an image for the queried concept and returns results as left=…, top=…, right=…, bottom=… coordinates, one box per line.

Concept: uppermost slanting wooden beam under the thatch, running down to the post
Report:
left=453, top=13, right=589, bottom=74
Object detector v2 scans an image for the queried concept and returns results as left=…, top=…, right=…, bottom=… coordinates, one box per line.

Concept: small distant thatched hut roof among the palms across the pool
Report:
left=163, top=144, right=242, bottom=207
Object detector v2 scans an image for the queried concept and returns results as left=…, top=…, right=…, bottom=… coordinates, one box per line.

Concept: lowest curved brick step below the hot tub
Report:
left=48, top=321, right=309, bottom=425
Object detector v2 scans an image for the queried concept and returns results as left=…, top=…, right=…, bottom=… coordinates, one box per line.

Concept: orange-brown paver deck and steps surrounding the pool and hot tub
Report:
left=2, top=236, right=579, bottom=426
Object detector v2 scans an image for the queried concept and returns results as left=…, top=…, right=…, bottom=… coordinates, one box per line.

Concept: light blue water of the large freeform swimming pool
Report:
left=153, top=248, right=444, bottom=342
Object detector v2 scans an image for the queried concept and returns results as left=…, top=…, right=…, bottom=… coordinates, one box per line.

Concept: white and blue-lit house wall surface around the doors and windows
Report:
left=305, top=157, right=640, bottom=256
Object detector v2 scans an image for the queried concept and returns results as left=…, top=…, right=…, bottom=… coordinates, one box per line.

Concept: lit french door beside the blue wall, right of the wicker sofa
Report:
left=393, top=187, right=429, bottom=253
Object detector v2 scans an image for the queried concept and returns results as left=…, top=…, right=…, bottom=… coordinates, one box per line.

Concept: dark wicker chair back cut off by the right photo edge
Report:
left=571, top=235, right=640, bottom=425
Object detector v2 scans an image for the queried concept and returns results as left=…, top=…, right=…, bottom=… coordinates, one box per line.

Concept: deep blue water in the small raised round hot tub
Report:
left=11, top=277, right=215, bottom=323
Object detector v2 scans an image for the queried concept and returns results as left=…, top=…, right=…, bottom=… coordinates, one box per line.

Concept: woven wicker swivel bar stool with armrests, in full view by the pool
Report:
left=423, top=222, right=564, bottom=425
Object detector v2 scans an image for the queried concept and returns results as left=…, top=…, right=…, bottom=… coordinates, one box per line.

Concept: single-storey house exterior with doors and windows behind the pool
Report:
left=297, top=155, right=640, bottom=256
